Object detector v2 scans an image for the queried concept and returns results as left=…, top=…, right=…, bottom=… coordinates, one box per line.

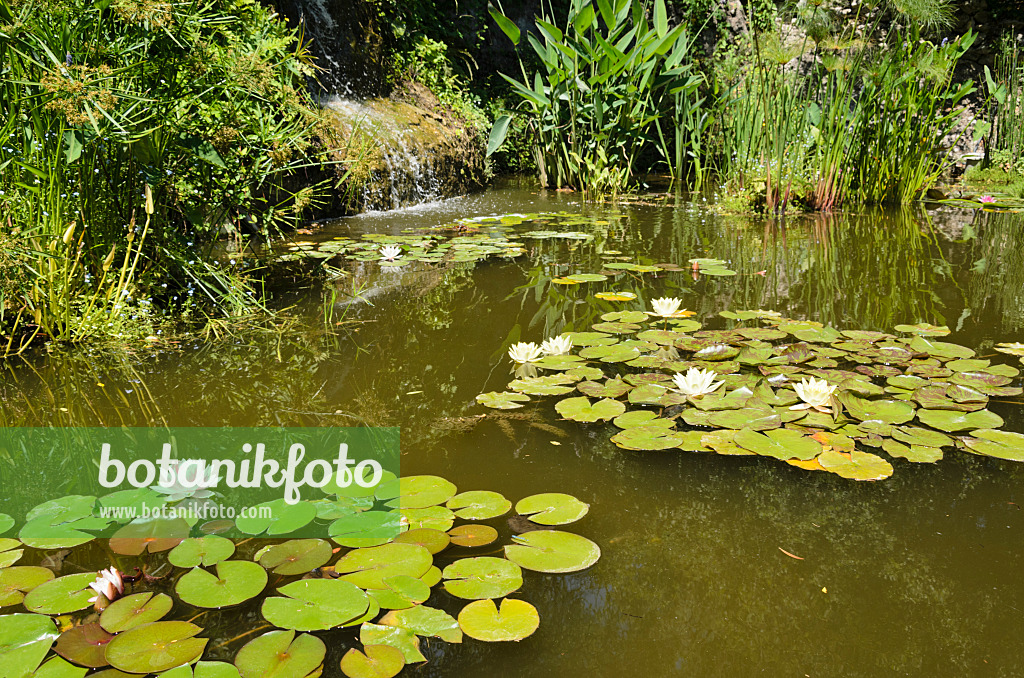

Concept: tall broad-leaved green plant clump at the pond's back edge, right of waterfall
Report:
left=492, top=0, right=699, bottom=199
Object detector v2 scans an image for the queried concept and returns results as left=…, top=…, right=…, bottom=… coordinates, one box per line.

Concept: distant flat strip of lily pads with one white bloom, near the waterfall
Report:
left=276, top=212, right=616, bottom=266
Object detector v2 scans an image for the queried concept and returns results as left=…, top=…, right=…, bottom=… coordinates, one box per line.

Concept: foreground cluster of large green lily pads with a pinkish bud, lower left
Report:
left=0, top=475, right=601, bottom=678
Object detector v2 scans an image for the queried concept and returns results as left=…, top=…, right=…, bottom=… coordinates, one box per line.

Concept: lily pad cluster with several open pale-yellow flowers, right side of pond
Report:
left=477, top=299, right=1024, bottom=480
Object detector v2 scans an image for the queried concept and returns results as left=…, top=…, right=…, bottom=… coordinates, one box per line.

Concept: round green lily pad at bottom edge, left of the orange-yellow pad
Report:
left=234, top=630, right=327, bottom=678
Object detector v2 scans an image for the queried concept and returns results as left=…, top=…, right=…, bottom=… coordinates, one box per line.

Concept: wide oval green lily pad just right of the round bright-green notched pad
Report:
left=260, top=579, right=370, bottom=631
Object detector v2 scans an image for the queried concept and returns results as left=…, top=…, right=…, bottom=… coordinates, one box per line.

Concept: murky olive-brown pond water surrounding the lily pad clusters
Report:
left=0, top=184, right=1024, bottom=678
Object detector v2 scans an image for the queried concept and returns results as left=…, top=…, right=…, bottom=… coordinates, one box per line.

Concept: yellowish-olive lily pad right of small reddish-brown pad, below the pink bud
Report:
left=105, top=622, right=207, bottom=678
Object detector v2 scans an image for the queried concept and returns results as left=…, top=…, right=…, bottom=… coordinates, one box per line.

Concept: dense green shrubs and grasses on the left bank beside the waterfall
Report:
left=0, top=0, right=327, bottom=352
